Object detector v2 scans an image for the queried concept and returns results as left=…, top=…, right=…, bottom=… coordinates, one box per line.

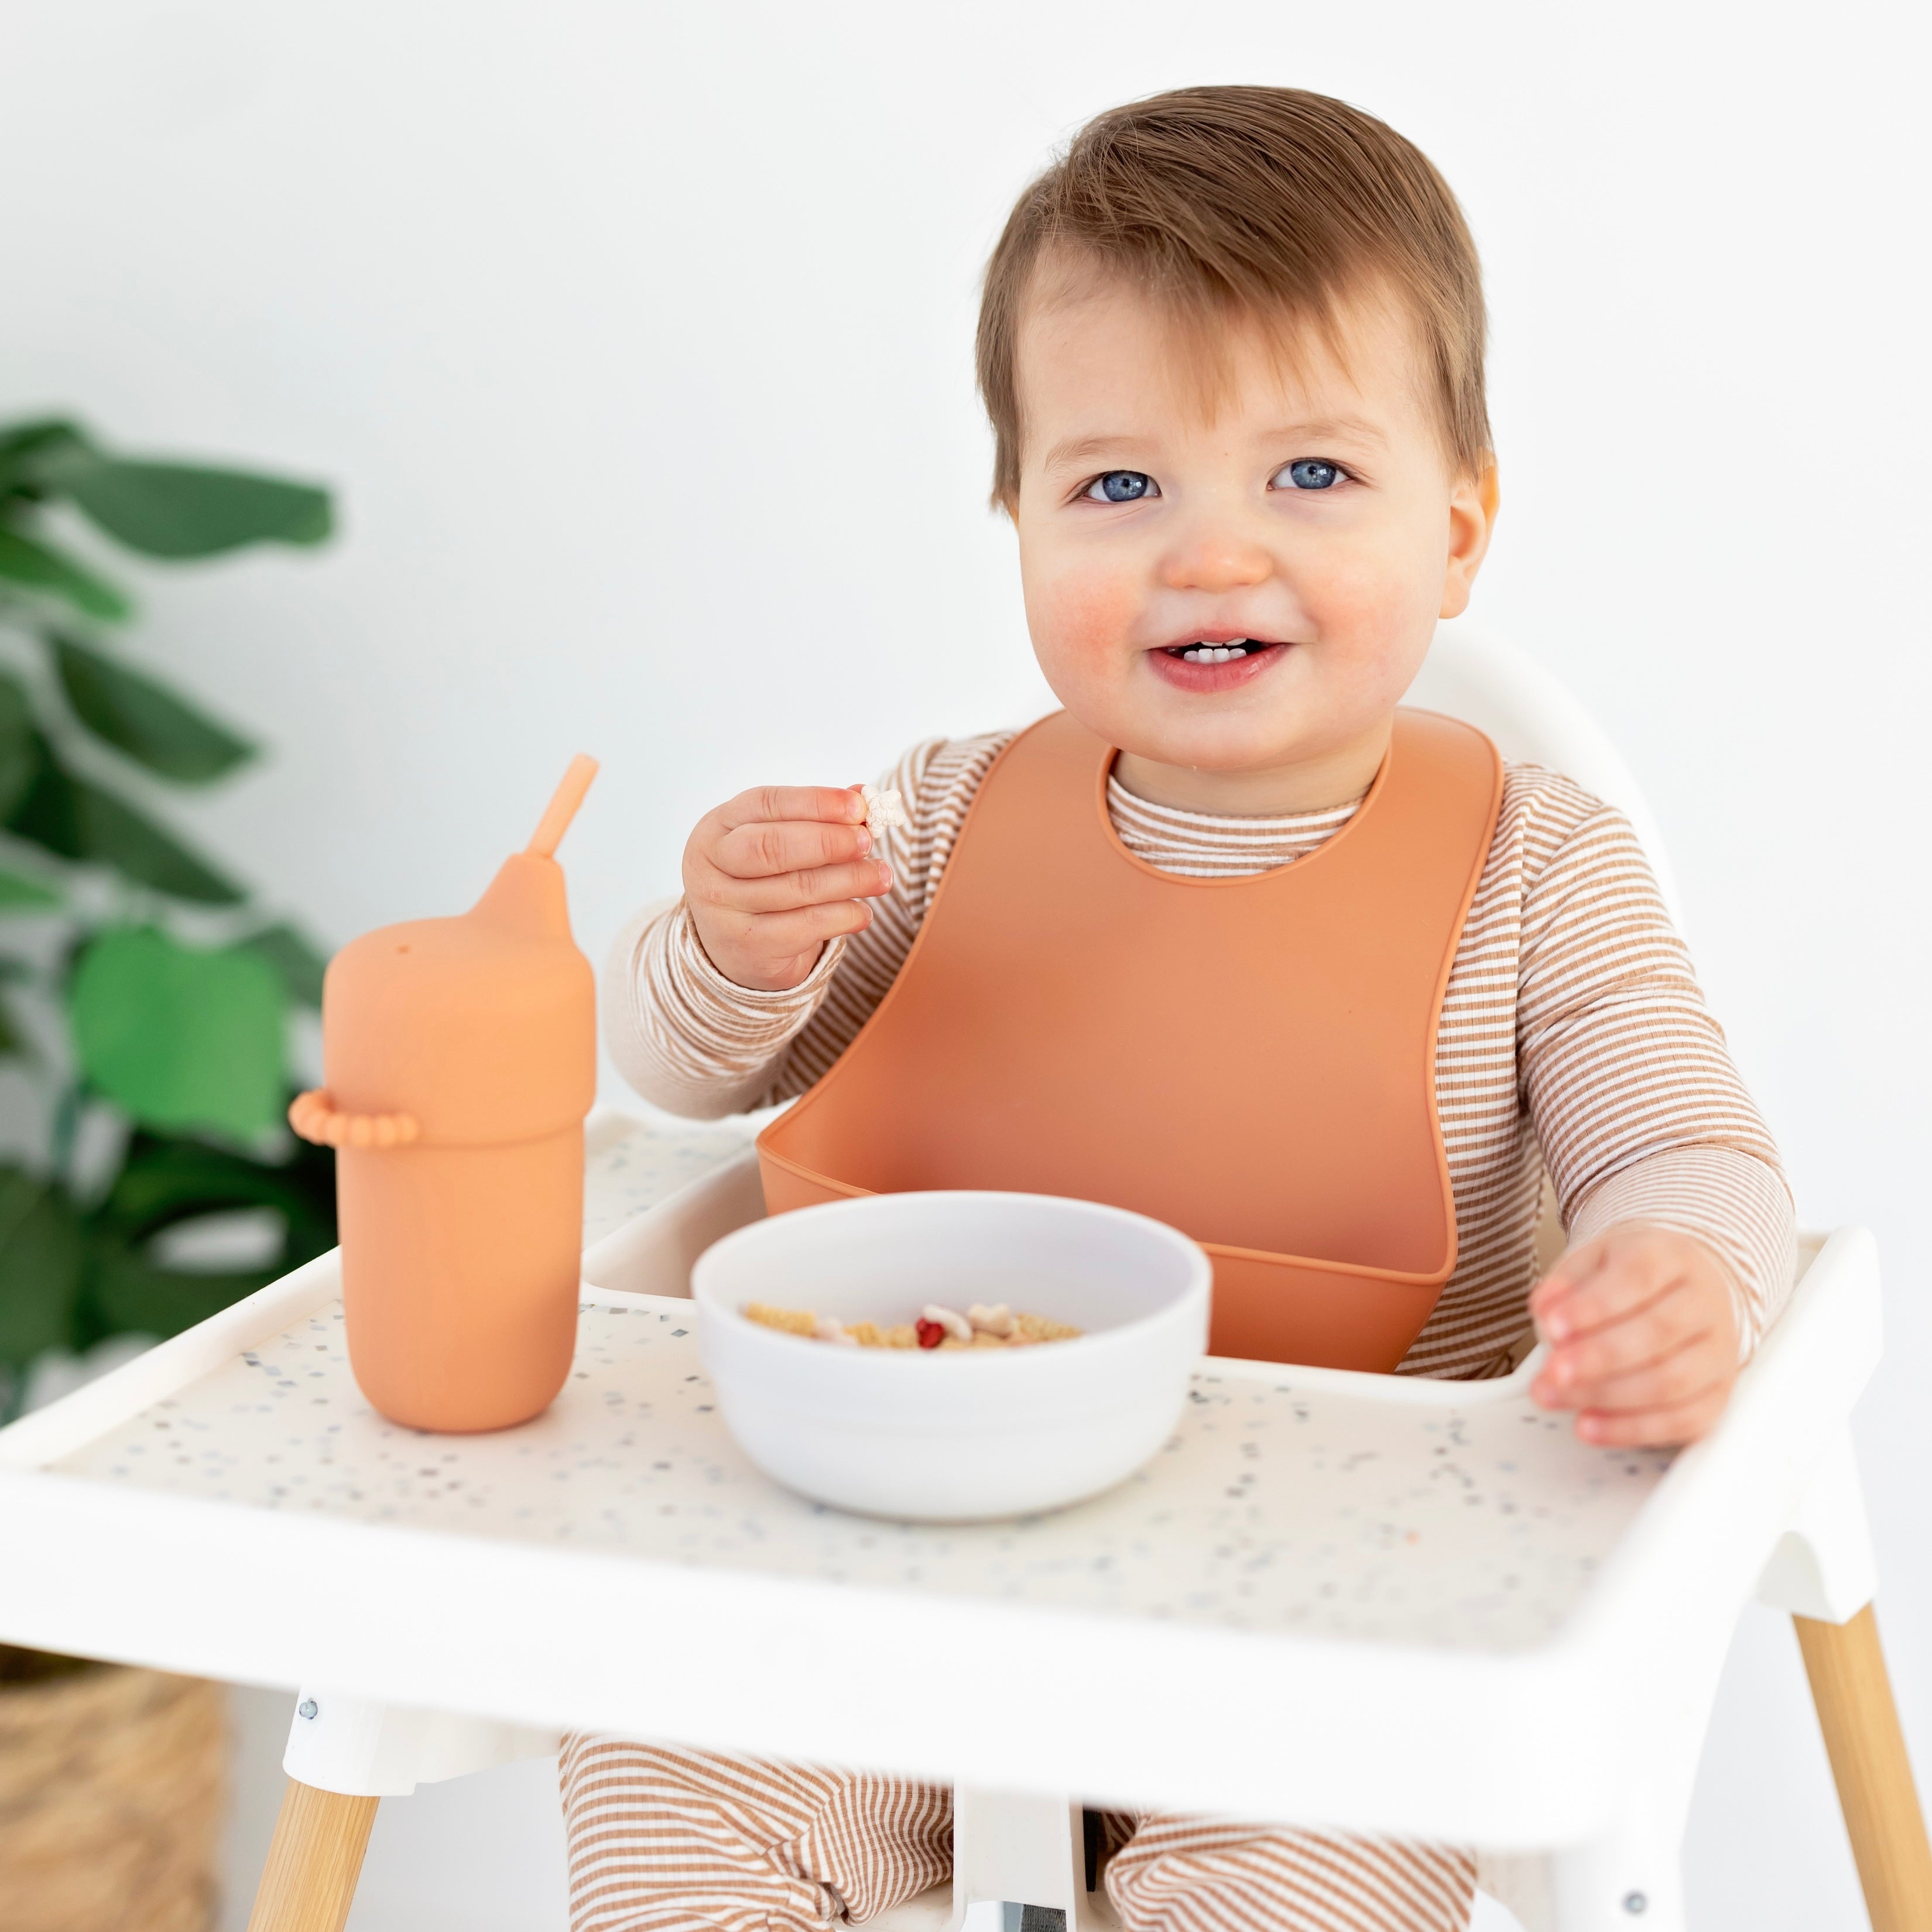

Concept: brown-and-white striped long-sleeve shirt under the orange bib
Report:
left=603, top=732, right=1795, bottom=1378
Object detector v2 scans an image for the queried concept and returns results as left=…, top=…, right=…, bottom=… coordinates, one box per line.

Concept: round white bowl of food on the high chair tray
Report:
left=691, top=1192, right=1211, bottom=1522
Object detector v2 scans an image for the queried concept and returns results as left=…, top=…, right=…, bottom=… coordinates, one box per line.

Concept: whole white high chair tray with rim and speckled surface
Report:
left=0, top=1119, right=1878, bottom=1843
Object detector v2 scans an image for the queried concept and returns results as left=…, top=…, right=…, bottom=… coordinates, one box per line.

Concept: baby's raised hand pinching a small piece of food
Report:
left=684, top=785, right=893, bottom=993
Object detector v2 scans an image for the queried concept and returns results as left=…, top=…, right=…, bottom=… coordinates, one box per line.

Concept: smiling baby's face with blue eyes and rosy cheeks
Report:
left=1015, top=270, right=1495, bottom=811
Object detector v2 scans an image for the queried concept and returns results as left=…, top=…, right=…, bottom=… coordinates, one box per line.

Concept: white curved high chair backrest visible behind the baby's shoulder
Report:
left=1406, top=618, right=1683, bottom=931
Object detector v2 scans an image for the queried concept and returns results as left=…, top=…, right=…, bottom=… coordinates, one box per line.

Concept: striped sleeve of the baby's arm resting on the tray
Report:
left=1517, top=800, right=1797, bottom=1354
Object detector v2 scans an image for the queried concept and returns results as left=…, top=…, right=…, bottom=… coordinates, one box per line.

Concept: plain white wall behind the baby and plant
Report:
left=0, top=0, right=1932, bottom=1932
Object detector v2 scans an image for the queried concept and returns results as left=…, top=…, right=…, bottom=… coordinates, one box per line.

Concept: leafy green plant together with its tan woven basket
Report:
left=0, top=419, right=334, bottom=1932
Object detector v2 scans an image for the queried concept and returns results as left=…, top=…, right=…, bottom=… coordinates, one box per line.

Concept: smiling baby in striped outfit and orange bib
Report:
left=564, top=87, right=1793, bottom=1932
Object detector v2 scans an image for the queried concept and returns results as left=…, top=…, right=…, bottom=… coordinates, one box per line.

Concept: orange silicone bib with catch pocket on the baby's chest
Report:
left=759, top=711, right=1503, bottom=1370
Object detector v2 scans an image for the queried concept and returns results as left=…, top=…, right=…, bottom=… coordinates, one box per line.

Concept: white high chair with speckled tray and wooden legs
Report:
left=0, top=630, right=1932, bottom=1932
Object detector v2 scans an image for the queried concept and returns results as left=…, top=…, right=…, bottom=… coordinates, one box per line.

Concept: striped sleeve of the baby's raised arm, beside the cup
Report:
left=601, top=732, right=1012, bottom=1121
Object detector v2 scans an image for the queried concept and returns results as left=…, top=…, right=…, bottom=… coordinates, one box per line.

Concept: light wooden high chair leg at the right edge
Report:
left=1791, top=1604, right=1932, bottom=1932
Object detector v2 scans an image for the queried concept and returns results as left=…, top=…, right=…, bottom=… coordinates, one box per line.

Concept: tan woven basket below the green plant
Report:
left=0, top=1652, right=226, bottom=1932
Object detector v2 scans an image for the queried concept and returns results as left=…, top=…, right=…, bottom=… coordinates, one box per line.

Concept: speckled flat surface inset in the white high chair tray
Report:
left=56, top=1296, right=1669, bottom=1650
